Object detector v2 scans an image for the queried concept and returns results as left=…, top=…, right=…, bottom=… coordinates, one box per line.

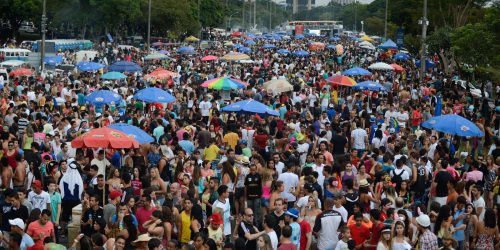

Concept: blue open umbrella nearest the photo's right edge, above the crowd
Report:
left=422, top=114, right=484, bottom=137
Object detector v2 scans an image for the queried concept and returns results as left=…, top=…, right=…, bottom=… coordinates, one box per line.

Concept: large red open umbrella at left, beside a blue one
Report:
left=71, top=128, right=139, bottom=149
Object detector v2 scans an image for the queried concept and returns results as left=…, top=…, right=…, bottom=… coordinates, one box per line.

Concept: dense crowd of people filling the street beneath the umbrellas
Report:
left=0, top=31, right=500, bottom=250
